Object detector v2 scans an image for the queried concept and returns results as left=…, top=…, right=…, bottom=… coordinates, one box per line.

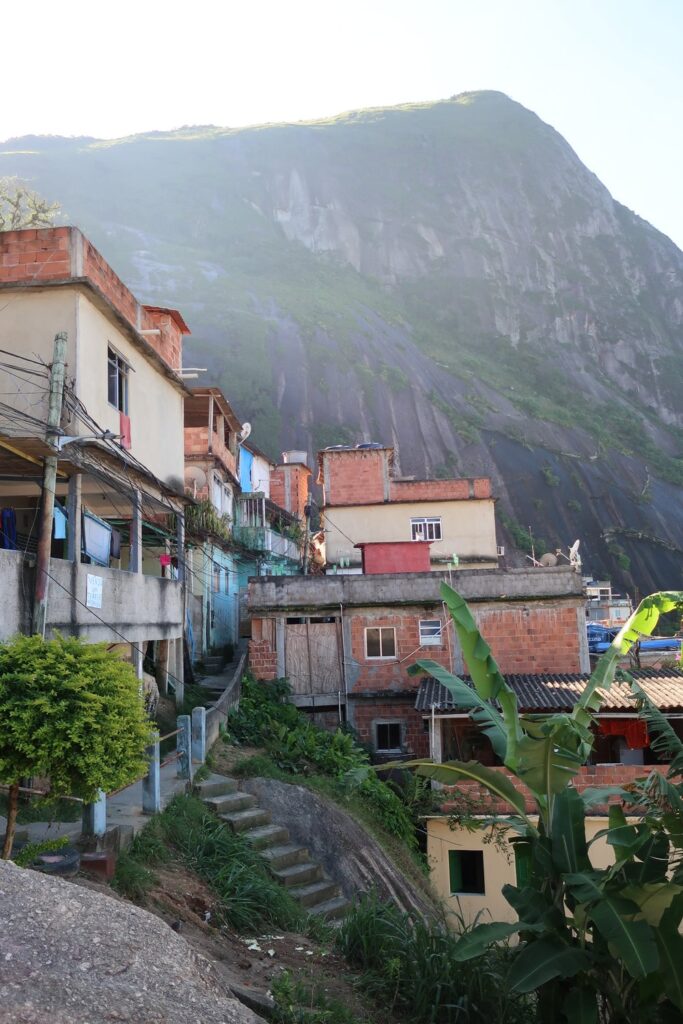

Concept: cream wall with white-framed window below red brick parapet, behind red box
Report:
left=325, top=498, right=498, bottom=567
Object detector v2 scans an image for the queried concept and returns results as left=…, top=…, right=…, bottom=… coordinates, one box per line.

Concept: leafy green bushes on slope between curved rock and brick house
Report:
left=228, top=675, right=417, bottom=850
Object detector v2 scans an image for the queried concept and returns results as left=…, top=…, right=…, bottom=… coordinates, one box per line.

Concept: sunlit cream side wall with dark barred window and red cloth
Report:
left=77, top=295, right=184, bottom=483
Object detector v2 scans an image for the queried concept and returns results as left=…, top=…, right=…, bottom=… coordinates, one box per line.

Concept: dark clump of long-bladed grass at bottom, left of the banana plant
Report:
left=337, top=893, right=533, bottom=1024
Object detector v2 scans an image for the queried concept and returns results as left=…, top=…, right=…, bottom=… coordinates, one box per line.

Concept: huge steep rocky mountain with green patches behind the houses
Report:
left=0, top=92, right=683, bottom=592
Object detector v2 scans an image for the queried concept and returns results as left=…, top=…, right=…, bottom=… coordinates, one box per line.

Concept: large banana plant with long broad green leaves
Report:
left=401, top=584, right=683, bottom=1024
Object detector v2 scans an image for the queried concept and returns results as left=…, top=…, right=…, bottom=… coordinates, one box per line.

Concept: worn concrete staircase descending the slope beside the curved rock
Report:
left=195, top=775, right=350, bottom=923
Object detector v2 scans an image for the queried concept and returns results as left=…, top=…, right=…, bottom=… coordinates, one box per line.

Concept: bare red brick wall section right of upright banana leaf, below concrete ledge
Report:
left=471, top=604, right=582, bottom=673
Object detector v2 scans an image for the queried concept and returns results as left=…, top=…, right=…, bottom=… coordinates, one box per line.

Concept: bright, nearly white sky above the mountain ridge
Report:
left=0, top=0, right=683, bottom=248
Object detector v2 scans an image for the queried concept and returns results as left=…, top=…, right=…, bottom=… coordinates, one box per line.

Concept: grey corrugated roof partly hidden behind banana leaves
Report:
left=415, top=669, right=683, bottom=713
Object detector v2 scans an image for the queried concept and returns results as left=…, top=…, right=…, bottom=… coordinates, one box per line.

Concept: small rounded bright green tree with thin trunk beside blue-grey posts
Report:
left=0, top=636, right=151, bottom=860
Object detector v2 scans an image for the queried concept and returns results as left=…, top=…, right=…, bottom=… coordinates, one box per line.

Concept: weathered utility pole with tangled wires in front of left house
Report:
left=31, top=331, right=67, bottom=637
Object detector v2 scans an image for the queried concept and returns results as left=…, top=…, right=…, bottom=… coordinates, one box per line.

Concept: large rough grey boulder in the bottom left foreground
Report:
left=0, top=861, right=262, bottom=1024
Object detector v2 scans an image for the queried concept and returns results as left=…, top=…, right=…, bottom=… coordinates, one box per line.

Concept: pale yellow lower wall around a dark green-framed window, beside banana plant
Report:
left=427, top=817, right=626, bottom=924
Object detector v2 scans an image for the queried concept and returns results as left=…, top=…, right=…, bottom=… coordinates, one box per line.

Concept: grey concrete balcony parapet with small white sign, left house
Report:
left=0, top=550, right=184, bottom=643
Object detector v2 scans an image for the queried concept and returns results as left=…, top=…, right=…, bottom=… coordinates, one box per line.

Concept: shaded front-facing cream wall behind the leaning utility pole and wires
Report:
left=0, top=288, right=77, bottom=428
